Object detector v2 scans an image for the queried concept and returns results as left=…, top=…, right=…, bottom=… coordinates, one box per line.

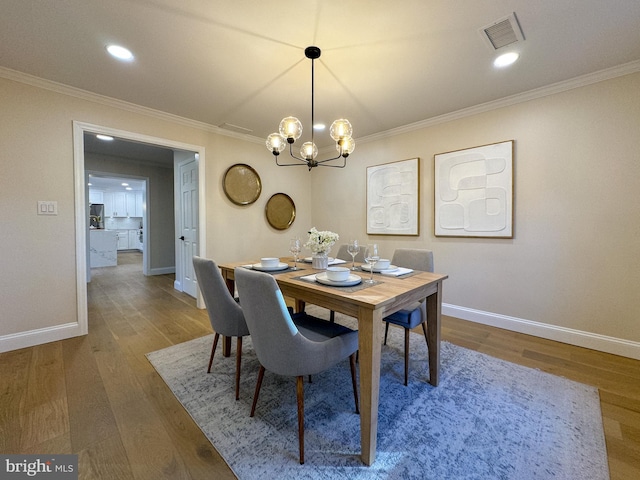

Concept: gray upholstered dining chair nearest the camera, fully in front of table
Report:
left=235, top=267, right=359, bottom=464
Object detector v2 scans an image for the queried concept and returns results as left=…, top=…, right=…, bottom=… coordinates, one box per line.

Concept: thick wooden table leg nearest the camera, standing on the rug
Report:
left=358, top=308, right=383, bottom=465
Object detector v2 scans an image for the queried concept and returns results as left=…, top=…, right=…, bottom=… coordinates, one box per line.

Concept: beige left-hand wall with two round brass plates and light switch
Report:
left=0, top=73, right=311, bottom=351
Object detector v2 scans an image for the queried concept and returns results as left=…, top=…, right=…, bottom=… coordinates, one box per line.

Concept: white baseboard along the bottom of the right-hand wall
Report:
left=442, top=303, right=640, bottom=360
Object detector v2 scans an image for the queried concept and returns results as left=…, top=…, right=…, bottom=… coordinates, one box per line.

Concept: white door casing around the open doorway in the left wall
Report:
left=73, top=121, right=206, bottom=334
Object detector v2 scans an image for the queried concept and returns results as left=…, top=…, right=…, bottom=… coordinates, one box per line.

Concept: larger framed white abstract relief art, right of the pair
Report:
left=434, top=140, right=514, bottom=238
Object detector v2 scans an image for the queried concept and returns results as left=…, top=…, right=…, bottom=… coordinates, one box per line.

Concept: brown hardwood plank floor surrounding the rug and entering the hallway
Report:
left=0, top=253, right=640, bottom=480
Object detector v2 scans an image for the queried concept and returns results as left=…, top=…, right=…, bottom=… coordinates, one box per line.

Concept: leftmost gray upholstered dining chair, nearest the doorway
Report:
left=193, top=256, right=249, bottom=400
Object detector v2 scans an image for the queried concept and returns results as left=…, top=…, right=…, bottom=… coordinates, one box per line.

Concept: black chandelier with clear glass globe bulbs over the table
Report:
left=266, top=46, right=356, bottom=171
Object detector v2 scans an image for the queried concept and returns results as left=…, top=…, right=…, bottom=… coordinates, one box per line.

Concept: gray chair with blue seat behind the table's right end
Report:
left=383, top=248, right=433, bottom=385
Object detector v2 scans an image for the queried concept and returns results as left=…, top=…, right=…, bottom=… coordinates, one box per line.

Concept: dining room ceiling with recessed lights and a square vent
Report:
left=0, top=0, right=640, bottom=146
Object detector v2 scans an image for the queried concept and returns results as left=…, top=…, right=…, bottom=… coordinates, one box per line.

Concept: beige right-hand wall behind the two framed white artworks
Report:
left=312, top=74, right=640, bottom=355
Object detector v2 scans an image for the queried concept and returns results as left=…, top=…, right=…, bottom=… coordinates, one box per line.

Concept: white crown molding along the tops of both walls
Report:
left=0, top=60, right=640, bottom=149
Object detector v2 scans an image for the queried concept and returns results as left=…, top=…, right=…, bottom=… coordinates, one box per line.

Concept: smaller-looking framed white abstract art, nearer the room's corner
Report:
left=367, top=158, right=420, bottom=235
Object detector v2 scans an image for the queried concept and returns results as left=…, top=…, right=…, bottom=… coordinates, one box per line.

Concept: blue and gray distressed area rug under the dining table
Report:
left=147, top=310, right=609, bottom=480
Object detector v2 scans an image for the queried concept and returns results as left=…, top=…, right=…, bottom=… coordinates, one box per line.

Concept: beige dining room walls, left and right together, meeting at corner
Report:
left=0, top=70, right=640, bottom=358
